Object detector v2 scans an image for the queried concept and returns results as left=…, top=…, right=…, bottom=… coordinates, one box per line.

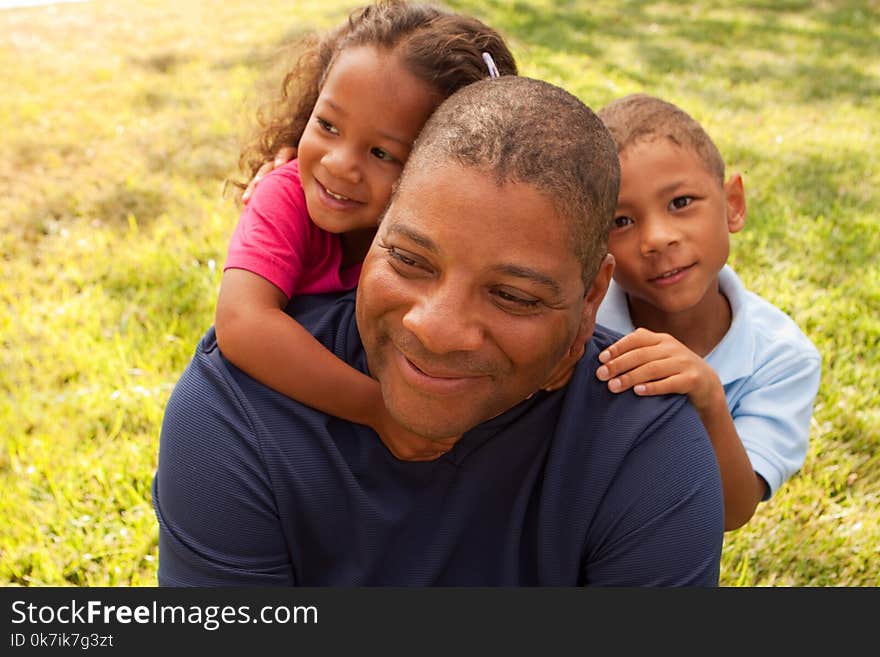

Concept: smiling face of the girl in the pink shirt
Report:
left=297, top=46, right=439, bottom=233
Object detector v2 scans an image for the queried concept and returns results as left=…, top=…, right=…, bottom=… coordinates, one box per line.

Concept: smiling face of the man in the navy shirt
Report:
left=356, top=163, right=610, bottom=440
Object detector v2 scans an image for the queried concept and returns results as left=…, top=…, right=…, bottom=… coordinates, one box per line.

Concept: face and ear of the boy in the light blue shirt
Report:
left=608, top=138, right=745, bottom=317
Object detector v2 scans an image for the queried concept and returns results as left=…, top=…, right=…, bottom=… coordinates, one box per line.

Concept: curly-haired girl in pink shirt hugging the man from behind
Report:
left=215, top=1, right=516, bottom=452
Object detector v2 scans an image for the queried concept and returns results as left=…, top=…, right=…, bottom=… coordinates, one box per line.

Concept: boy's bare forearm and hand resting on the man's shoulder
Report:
left=596, top=328, right=766, bottom=531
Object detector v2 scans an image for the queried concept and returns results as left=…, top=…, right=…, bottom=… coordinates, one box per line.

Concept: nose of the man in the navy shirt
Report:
left=403, top=282, right=485, bottom=354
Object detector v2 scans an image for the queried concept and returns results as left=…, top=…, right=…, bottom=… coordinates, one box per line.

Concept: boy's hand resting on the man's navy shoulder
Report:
left=596, top=328, right=720, bottom=411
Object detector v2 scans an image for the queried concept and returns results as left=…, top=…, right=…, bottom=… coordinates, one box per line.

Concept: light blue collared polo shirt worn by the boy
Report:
left=597, top=265, right=822, bottom=499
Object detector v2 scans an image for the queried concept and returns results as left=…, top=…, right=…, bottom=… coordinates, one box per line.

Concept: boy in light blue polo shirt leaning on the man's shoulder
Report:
left=596, top=94, right=821, bottom=531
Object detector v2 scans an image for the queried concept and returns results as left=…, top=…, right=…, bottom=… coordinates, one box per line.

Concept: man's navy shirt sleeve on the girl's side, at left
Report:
left=153, top=330, right=295, bottom=586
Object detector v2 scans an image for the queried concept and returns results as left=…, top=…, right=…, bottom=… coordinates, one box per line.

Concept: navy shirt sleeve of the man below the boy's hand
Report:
left=583, top=398, right=724, bottom=587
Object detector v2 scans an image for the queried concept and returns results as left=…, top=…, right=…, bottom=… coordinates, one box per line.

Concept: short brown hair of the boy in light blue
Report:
left=599, top=94, right=724, bottom=184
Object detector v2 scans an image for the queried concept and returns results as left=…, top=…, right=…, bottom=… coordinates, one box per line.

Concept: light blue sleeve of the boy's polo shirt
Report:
left=731, top=351, right=821, bottom=500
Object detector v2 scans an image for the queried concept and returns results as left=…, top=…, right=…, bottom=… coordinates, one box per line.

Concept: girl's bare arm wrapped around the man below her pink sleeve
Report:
left=214, top=269, right=387, bottom=432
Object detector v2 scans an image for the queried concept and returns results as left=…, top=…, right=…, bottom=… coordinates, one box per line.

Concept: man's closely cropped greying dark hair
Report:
left=401, top=75, right=620, bottom=285
